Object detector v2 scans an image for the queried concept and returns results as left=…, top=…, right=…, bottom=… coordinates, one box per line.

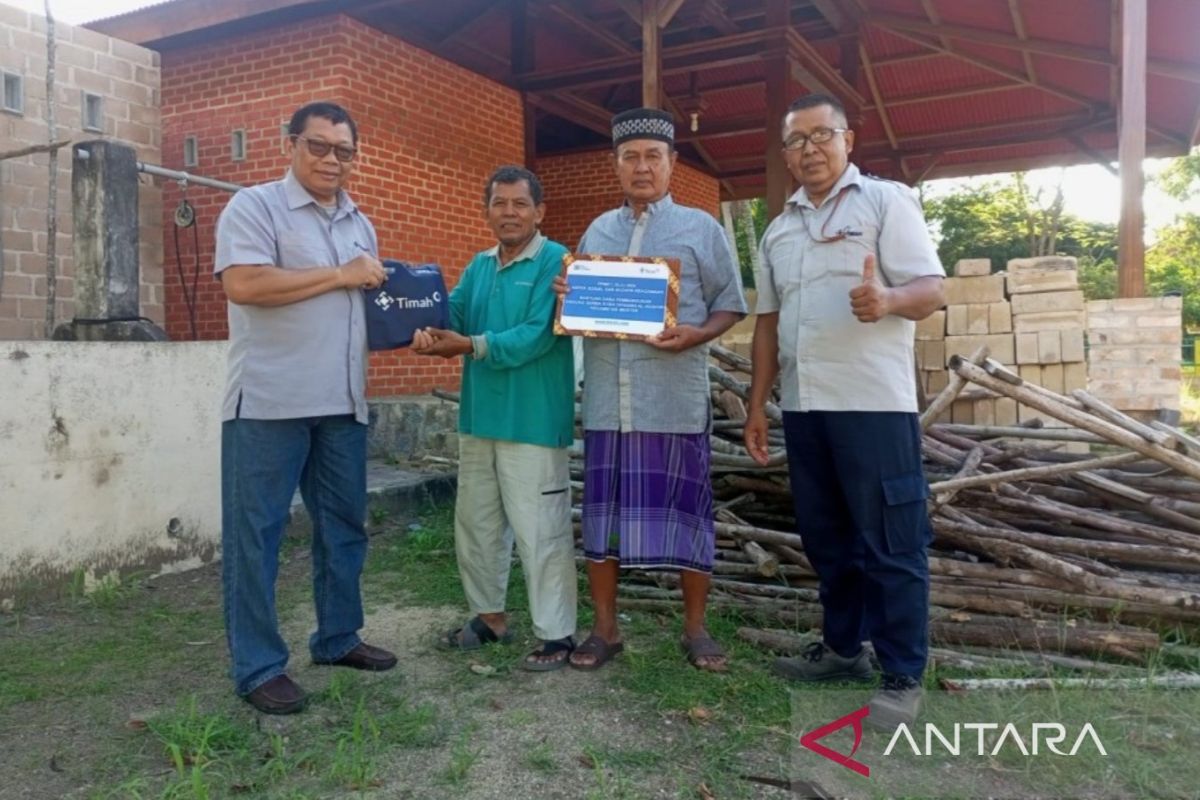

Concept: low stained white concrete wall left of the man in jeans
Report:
left=0, top=342, right=227, bottom=599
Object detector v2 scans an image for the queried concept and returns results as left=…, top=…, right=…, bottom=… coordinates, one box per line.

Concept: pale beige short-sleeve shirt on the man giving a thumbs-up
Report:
left=755, top=164, right=946, bottom=411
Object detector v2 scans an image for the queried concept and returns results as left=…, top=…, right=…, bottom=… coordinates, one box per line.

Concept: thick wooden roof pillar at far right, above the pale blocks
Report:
left=1117, top=0, right=1146, bottom=297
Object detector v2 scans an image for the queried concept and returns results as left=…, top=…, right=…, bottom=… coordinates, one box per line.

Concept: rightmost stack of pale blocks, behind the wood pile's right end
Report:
left=1087, top=297, right=1183, bottom=416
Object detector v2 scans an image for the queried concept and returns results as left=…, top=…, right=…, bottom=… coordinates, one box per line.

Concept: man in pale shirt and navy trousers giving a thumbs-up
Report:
left=745, top=95, right=944, bottom=724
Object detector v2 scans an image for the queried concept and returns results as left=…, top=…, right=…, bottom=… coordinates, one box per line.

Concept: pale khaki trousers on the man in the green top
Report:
left=454, top=434, right=576, bottom=639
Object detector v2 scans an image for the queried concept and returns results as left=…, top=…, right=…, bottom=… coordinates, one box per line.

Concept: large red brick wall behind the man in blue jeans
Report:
left=162, top=16, right=523, bottom=396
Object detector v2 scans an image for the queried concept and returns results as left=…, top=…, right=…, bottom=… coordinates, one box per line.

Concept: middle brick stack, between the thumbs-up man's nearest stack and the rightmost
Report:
left=1006, top=255, right=1087, bottom=425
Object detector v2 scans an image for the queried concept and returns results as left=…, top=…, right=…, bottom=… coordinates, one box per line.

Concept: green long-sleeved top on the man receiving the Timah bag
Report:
left=450, top=234, right=575, bottom=447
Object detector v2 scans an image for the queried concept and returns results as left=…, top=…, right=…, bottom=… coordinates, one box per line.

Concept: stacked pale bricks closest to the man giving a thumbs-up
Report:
left=918, top=258, right=1018, bottom=425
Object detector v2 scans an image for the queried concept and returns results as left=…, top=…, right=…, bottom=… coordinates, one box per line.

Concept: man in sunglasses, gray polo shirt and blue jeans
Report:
left=215, top=103, right=396, bottom=714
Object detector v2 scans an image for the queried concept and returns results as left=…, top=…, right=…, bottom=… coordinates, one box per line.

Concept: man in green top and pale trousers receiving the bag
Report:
left=413, top=167, right=576, bottom=672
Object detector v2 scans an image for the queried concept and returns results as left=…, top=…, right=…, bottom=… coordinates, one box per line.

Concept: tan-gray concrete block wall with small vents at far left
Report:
left=0, top=5, right=164, bottom=339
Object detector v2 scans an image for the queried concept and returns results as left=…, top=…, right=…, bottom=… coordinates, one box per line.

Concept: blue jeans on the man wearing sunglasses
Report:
left=221, top=415, right=367, bottom=696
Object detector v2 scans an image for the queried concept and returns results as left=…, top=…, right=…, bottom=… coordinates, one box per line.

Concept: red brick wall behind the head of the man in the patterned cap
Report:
left=538, top=149, right=721, bottom=249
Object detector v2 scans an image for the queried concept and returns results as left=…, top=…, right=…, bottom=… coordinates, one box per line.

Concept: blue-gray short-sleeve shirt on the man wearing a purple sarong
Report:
left=580, top=194, right=746, bottom=433
